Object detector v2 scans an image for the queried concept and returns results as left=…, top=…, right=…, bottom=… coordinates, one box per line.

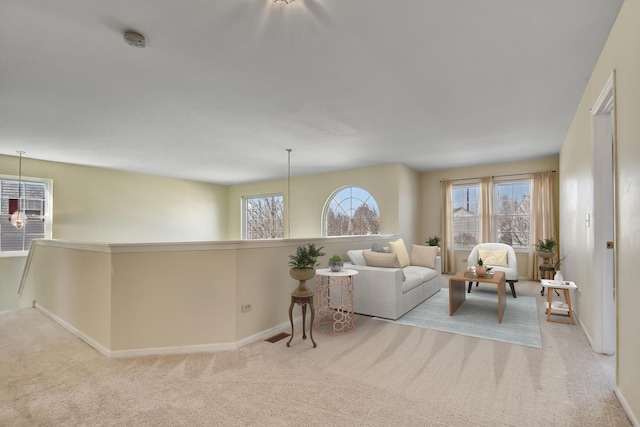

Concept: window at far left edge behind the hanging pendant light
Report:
left=0, top=177, right=52, bottom=255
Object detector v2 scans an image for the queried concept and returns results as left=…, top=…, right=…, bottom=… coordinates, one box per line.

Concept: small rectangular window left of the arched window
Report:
left=242, top=194, right=284, bottom=240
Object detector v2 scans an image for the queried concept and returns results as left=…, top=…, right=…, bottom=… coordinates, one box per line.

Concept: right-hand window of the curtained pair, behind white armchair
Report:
left=493, top=179, right=531, bottom=249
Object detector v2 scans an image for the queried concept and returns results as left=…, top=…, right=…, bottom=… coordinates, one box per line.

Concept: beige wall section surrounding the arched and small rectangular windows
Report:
left=227, top=163, right=418, bottom=245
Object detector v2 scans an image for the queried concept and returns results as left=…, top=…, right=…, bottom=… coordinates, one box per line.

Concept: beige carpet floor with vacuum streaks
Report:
left=0, top=278, right=631, bottom=426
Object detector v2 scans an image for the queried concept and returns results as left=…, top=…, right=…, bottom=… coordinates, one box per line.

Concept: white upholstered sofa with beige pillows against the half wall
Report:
left=344, top=249, right=442, bottom=320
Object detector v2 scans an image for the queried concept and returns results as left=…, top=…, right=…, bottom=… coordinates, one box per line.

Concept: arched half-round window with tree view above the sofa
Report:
left=322, top=187, right=380, bottom=236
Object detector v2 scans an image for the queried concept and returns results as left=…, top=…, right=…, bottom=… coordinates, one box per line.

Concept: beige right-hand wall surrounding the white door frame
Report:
left=560, top=0, right=640, bottom=425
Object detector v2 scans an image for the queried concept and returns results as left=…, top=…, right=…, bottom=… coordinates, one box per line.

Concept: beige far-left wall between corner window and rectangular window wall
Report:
left=0, top=155, right=227, bottom=243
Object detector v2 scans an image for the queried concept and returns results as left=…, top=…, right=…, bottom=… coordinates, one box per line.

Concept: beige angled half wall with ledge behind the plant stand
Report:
left=20, top=235, right=397, bottom=356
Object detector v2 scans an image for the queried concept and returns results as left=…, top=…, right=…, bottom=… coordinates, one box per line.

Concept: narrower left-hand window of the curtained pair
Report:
left=453, top=184, right=480, bottom=247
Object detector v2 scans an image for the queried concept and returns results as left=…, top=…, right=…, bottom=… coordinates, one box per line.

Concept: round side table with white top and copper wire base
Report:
left=314, top=268, right=358, bottom=335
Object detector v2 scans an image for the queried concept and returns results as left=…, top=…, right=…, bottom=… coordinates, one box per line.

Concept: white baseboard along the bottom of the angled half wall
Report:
left=33, top=303, right=302, bottom=359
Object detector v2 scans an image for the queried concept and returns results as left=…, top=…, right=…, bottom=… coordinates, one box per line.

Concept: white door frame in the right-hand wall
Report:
left=586, top=72, right=616, bottom=354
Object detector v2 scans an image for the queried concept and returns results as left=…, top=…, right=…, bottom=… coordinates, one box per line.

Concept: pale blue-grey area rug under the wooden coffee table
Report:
left=376, top=288, right=542, bottom=348
